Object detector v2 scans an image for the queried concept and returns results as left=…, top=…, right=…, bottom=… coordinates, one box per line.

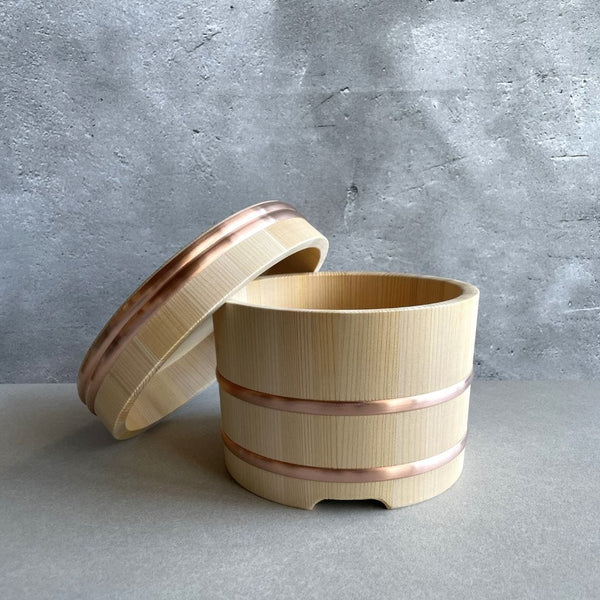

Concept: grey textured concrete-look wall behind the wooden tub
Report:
left=0, top=0, right=600, bottom=382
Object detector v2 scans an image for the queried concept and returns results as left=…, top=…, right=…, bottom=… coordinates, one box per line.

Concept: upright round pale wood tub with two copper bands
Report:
left=214, top=273, right=479, bottom=509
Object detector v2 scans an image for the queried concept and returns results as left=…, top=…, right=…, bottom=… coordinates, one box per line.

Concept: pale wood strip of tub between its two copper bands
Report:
left=220, top=389, right=469, bottom=469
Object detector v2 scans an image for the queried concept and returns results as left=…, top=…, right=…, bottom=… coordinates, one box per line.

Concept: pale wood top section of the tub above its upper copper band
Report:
left=214, top=273, right=478, bottom=401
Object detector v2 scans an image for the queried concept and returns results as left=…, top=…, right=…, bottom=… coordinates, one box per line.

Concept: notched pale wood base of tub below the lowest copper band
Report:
left=225, top=448, right=464, bottom=510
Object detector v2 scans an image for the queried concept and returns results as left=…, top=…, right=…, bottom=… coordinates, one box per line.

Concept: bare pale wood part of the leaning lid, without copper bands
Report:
left=96, top=218, right=328, bottom=439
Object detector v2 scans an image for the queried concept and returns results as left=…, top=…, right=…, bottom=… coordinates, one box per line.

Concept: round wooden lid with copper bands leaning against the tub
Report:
left=77, top=202, right=328, bottom=439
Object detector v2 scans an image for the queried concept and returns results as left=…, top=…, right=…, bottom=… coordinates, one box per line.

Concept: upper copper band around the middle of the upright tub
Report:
left=217, top=371, right=473, bottom=416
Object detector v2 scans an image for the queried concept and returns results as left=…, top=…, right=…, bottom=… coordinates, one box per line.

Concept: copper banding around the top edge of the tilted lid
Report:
left=77, top=202, right=300, bottom=412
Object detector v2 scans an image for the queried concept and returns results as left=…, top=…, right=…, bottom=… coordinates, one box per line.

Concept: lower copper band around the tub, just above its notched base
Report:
left=221, top=430, right=467, bottom=483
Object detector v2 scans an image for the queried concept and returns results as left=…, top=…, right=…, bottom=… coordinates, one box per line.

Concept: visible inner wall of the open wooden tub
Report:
left=235, top=273, right=463, bottom=310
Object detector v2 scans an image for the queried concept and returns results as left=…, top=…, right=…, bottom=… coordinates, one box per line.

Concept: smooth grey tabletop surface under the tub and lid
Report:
left=0, top=381, right=600, bottom=600
